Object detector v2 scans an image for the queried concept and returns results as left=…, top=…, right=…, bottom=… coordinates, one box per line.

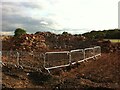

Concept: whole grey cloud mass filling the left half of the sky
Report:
left=2, top=2, right=62, bottom=33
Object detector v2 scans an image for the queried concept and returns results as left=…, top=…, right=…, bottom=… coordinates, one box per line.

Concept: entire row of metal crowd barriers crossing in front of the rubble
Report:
left=0, top=46, right=101, bottom=73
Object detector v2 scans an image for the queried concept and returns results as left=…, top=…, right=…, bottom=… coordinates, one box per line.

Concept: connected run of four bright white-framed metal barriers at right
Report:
left=44, top=46, right=101, bottom=70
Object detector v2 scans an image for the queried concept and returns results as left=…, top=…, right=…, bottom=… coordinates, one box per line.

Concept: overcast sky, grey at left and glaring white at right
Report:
left=0, top=0, right=119, bottom=34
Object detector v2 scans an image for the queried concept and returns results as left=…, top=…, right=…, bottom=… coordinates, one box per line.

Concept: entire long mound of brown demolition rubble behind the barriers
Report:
left=2, top=32, right=86, bottom=52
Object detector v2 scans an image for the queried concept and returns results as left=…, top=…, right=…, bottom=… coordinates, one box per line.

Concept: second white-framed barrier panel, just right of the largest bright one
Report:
left=70, top=49, right=84, bottom=64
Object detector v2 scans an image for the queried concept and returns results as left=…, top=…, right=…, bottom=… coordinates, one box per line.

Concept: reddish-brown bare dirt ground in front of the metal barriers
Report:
left=1, top=52, right=120, bottom=90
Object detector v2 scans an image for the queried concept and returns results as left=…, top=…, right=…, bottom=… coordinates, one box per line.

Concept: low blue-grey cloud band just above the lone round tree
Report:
left=2, top=15, right=57, bottom=33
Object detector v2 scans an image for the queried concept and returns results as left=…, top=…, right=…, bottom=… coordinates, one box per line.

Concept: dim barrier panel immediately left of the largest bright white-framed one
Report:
left=19, top=52, right=44, bottom=69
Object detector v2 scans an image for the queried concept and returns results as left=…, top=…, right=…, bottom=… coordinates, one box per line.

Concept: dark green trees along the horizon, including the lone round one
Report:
left=14, top=28, right=120, bottom=39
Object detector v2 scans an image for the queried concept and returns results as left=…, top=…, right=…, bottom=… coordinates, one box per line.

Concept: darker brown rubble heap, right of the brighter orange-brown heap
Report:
left=36, top=32, right=85, bottom=51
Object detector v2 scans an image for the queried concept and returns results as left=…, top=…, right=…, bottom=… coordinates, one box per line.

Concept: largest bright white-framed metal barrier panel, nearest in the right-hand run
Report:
left=45, top=51, right=69, bottom=69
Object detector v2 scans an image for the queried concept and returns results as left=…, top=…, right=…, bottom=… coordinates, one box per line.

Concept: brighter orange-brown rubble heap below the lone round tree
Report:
left=3, top=34, right=47, bottom=51
